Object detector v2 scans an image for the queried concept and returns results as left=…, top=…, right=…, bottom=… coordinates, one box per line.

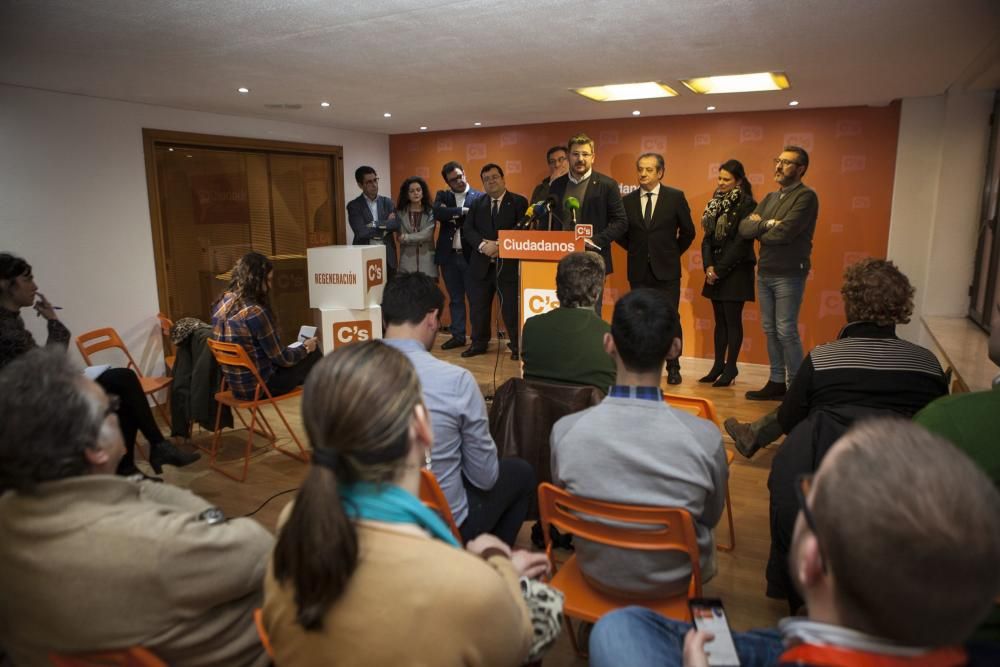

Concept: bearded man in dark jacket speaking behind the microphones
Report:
left=549, top=134, right=628, bottom=316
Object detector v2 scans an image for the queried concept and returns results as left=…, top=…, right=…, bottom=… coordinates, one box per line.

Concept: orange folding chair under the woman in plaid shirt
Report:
left=208, top=340, right=309, bottom=482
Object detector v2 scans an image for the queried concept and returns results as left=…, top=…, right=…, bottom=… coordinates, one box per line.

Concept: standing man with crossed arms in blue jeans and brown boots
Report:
left=740, top=146, right=819, bottom=401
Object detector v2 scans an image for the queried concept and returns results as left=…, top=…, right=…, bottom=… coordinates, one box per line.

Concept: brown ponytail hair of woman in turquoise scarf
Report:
left=274, top=341, right=421, bottom=630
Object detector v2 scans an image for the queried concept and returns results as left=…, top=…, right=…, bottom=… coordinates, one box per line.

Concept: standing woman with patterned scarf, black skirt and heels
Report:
left=698, top=160, right=757, bottom=387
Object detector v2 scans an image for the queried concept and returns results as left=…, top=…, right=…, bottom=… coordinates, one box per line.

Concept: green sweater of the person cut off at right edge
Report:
left=913, top=385, right=1000, bottom=645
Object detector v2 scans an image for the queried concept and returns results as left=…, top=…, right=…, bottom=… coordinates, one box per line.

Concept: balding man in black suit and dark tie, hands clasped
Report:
left=618, top=153, right=694, bottom=384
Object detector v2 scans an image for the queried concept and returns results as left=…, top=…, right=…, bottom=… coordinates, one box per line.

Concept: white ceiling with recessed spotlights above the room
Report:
left=0, top=0, right=1000, bottom=134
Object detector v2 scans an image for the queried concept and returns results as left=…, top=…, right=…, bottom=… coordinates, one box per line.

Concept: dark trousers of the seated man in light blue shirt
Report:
left=458, top=457, right=537, bottom=546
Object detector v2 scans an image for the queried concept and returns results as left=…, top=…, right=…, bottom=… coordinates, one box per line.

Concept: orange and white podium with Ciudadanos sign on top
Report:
left=498, top=230, right=584, bottom=340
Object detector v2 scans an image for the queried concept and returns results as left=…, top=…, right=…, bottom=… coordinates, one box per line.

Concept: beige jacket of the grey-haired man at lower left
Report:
left=0, top=475, right=274, bottom=666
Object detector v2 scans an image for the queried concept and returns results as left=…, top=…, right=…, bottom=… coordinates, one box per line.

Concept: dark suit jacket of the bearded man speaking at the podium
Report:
left=549, top=171, right=628, bottom=273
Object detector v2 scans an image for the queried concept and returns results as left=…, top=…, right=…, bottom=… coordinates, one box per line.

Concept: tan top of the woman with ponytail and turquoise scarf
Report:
left=264, top=510, right=532, bottom=667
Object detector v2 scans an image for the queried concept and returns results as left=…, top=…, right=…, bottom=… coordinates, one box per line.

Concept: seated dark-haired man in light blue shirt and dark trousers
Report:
left=382, top=273, right=535, bottom=546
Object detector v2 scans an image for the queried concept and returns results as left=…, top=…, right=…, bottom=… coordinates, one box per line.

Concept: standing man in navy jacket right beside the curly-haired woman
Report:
left=434, top=161, right=483, bottom=350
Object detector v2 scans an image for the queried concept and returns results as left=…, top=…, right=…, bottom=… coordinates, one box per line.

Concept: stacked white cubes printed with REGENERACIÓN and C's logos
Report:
left=306, top=245, right=386, bottom=353
